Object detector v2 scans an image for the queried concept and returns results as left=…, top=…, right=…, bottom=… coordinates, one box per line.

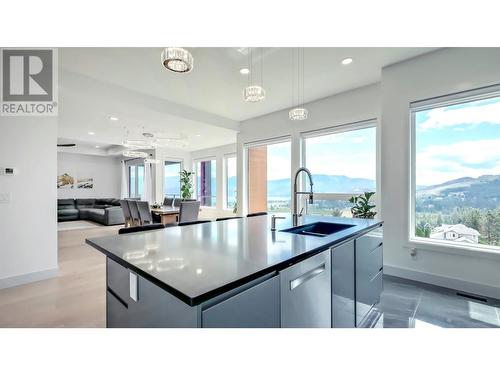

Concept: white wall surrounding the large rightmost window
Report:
left=381, top=48, right=500, bottom=298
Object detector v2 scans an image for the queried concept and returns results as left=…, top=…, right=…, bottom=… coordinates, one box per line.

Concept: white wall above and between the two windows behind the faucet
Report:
left=237, top=84, right=380, bottom=214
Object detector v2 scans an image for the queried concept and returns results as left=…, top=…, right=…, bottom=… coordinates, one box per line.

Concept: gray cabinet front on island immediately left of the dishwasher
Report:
left=202, top=276, right=280, bottom=328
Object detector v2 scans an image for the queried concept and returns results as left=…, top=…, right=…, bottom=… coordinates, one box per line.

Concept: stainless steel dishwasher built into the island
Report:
left=280, top=250, right=332, bottom=328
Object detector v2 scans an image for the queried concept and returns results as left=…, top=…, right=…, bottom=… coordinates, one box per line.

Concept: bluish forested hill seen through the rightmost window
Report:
left=416, top=175, right=500, bottom=211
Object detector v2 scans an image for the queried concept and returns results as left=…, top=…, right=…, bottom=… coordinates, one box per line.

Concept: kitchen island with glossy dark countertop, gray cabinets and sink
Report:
left=86, top=215, right=383, bottom=327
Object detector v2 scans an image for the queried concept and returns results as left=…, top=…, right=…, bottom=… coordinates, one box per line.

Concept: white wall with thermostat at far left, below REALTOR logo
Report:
left=0, top=117, right=57, bottom=288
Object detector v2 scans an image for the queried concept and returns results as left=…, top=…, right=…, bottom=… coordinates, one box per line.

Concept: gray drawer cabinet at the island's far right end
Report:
left=355, top=226, right=383, bottom=326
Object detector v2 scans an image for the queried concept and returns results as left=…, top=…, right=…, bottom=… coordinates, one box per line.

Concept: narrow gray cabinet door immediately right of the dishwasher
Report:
left=331, top=240, right=356, bottom=328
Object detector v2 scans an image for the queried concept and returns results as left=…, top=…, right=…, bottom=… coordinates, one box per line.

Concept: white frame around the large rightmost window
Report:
left=406, top=85, right=500, bottom=255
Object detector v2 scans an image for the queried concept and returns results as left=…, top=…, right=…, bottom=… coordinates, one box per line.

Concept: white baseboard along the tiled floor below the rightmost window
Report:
left=384, top=264, right=500, bottom=299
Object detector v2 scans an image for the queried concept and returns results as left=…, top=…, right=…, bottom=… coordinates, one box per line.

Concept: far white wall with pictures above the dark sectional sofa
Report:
left=57, top=152, right=121, bottom=199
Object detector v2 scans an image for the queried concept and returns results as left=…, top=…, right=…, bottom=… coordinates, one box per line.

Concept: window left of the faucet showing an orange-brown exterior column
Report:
left=248, top=141, right=291, bottom=213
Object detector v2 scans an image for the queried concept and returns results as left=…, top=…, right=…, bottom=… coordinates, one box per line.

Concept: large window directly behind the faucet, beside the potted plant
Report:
left=303, top=123, right=377, bottom=217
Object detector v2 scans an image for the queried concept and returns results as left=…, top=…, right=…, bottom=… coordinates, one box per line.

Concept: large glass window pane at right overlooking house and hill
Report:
left=410, top=90, right=500, bottom=253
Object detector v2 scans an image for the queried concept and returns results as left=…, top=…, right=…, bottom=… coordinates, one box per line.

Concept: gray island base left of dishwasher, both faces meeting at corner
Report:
left=106, top=258, right=280, bottom=328
